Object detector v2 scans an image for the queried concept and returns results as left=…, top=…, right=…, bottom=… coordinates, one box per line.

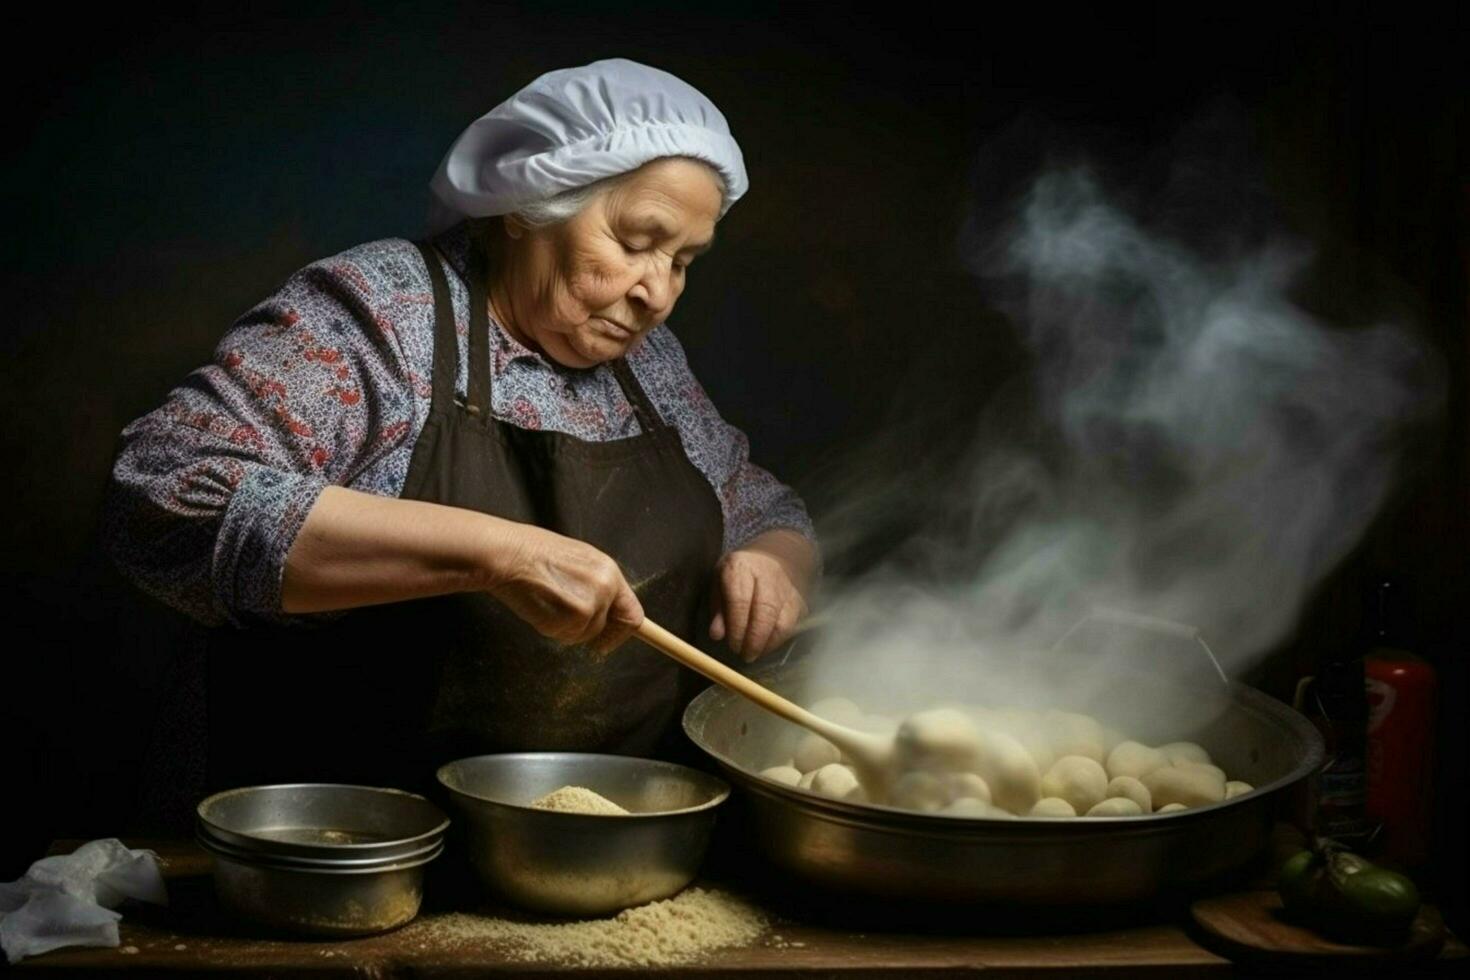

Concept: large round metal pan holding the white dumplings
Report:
left=684, top=631, right=1323, bottom=907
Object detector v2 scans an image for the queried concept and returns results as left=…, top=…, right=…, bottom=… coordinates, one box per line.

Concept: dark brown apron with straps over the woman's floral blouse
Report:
left=209, top=224, right=723, bottom=790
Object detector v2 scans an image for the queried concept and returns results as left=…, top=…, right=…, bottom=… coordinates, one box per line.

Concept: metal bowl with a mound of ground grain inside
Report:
left=438, top=752, right=731, bottom=917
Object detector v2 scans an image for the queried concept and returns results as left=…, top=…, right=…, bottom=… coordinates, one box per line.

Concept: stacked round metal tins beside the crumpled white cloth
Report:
left=196, top=783, right=448, bottom=936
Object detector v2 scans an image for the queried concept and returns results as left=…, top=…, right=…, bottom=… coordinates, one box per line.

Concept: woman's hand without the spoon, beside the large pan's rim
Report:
left=710, top=530, right=811, bottom=663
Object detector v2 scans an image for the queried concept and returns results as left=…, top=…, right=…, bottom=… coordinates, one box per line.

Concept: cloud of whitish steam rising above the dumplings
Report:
left=799, top=130, right=1435, bottom=717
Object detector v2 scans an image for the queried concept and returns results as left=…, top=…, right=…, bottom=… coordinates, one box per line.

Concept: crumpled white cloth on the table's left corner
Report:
left=0, top=837, right=169, bottom=962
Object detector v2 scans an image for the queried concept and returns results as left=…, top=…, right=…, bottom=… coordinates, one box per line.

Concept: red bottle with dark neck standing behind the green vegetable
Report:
left=1363, top=580, right=1436, bottom=867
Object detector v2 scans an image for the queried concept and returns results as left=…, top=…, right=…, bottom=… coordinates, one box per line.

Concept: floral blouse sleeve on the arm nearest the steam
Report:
left=631, top=326, right=817, bottom=564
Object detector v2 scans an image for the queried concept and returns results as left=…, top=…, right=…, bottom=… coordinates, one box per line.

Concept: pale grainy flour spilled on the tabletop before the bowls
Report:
left=410, top=887, right=766, bottom=967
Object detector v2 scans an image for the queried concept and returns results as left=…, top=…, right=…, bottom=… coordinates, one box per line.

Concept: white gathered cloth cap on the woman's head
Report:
left=428, top=57, right=750, bottom=235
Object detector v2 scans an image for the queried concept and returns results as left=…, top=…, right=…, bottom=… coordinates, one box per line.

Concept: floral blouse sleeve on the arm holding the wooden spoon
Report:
left=104, top=245, right=413, bottom=626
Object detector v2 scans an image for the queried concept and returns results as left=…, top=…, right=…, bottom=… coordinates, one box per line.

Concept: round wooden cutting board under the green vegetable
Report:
left=1189, top=889, right=1445, bottom=967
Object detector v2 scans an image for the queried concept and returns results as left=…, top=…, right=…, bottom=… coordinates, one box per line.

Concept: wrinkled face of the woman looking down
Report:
left=491, top=157, right=722, bottom=367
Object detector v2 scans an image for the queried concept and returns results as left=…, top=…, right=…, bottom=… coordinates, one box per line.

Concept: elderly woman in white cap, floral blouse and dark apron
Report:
left=109, top=59, right=816, bottom=785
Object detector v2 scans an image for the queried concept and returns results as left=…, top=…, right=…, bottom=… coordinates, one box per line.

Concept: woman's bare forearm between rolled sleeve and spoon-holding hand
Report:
left=281, top=486, right=523, bottom=613
